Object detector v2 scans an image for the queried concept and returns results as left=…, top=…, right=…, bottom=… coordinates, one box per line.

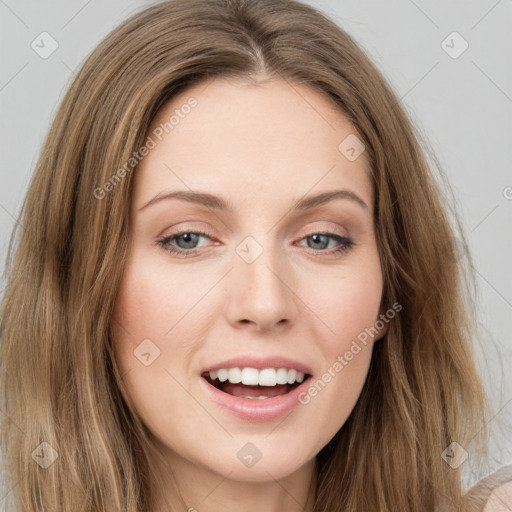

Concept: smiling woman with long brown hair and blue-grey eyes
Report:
left=0, top=0, right=511, bottom=512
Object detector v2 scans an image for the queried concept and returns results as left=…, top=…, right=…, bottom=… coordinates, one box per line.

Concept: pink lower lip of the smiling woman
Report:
left=200, top=377, right=311, bottom=422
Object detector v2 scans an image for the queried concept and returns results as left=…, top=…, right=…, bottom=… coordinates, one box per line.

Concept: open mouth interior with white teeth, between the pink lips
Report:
left=201, top=368, right=311, bottom=400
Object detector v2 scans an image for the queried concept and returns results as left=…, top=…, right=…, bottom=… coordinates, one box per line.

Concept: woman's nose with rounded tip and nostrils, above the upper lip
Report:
left=226, top=242, right=298, bottom=332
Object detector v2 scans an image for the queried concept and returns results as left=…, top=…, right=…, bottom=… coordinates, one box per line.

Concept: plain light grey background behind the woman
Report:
left=0, top=0, right=512, bottom=496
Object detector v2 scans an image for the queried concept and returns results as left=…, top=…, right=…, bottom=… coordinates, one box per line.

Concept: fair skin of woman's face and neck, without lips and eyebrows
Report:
left=113, top=78, right=385, bottom=512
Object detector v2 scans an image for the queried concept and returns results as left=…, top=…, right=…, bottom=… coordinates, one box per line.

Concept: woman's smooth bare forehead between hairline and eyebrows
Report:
left=135, top=78, right=372, bottom=210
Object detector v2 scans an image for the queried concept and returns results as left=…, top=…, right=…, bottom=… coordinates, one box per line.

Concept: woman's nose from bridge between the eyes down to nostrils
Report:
left=227, top=230, right=296, bottom=329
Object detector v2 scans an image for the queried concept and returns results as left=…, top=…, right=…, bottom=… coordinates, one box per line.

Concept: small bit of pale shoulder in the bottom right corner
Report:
left=466, top=466, right=512, bottom=512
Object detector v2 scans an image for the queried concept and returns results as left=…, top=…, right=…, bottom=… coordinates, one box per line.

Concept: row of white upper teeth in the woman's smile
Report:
left=210, top=368, right=304, bottom=386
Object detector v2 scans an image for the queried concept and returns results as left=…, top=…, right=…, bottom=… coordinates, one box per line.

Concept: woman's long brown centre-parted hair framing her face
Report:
left=0, top=0, right=487, bottom=512
